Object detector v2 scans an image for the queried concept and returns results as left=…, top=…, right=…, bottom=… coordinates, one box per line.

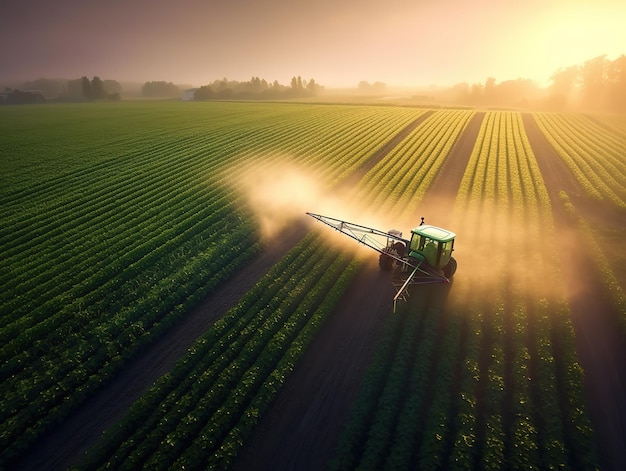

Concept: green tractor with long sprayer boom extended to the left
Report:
left=306, top=213, right=457, bottom=311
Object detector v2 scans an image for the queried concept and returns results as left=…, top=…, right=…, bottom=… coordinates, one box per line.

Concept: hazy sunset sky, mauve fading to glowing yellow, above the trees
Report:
left=0, top=0, right=626, bottom=87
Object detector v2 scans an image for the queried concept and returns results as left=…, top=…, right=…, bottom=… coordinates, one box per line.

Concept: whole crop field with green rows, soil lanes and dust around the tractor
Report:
left=0, top=102, right=626, bottom=470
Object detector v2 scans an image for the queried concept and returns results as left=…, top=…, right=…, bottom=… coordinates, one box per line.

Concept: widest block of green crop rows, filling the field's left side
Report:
left=0, top=102, right=419, bottom=464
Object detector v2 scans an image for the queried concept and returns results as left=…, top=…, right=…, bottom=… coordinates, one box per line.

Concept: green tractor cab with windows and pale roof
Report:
left=409, top=224, right=456, bottom=271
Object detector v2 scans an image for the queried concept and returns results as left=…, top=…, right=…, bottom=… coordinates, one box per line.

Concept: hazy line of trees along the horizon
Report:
left=0, top=55, right=626, bottom=113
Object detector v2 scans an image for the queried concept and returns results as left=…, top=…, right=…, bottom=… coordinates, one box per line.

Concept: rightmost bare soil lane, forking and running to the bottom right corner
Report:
left=522, top=113, right=626, bottom=470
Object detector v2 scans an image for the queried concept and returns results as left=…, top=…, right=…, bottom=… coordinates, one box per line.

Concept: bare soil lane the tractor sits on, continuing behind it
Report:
left=235, top=113, right=484, bottom=471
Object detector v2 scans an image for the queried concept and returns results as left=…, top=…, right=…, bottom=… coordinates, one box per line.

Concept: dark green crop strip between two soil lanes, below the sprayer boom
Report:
left=82, top=242, right=357, bottom=469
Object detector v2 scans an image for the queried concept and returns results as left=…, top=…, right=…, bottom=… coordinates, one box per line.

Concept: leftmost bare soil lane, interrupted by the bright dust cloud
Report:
left=15, top=111, right=433, bottom=471
